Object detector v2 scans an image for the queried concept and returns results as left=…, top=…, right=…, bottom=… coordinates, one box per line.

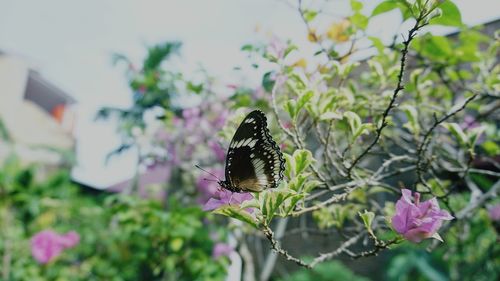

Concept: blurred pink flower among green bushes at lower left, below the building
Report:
left=31, top=230, right=80, bottom=264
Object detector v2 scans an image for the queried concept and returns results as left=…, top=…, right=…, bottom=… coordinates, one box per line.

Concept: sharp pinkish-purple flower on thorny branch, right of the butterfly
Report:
left=392, top=189, right=453, bottom=243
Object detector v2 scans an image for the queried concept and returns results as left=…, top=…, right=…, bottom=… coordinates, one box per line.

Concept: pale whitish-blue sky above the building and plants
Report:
left=0, top=0, right=500, bottom=187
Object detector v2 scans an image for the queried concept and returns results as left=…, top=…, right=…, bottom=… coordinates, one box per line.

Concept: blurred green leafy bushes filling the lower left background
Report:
left=0, top=154, right=227, bottom=281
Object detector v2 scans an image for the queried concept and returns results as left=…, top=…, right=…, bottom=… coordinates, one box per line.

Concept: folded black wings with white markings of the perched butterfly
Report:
left=225, top=110, right=285, bottom=192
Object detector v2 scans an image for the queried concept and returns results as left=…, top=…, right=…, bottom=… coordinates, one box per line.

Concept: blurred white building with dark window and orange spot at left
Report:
left=0, top=52, right=76, bottom=166
